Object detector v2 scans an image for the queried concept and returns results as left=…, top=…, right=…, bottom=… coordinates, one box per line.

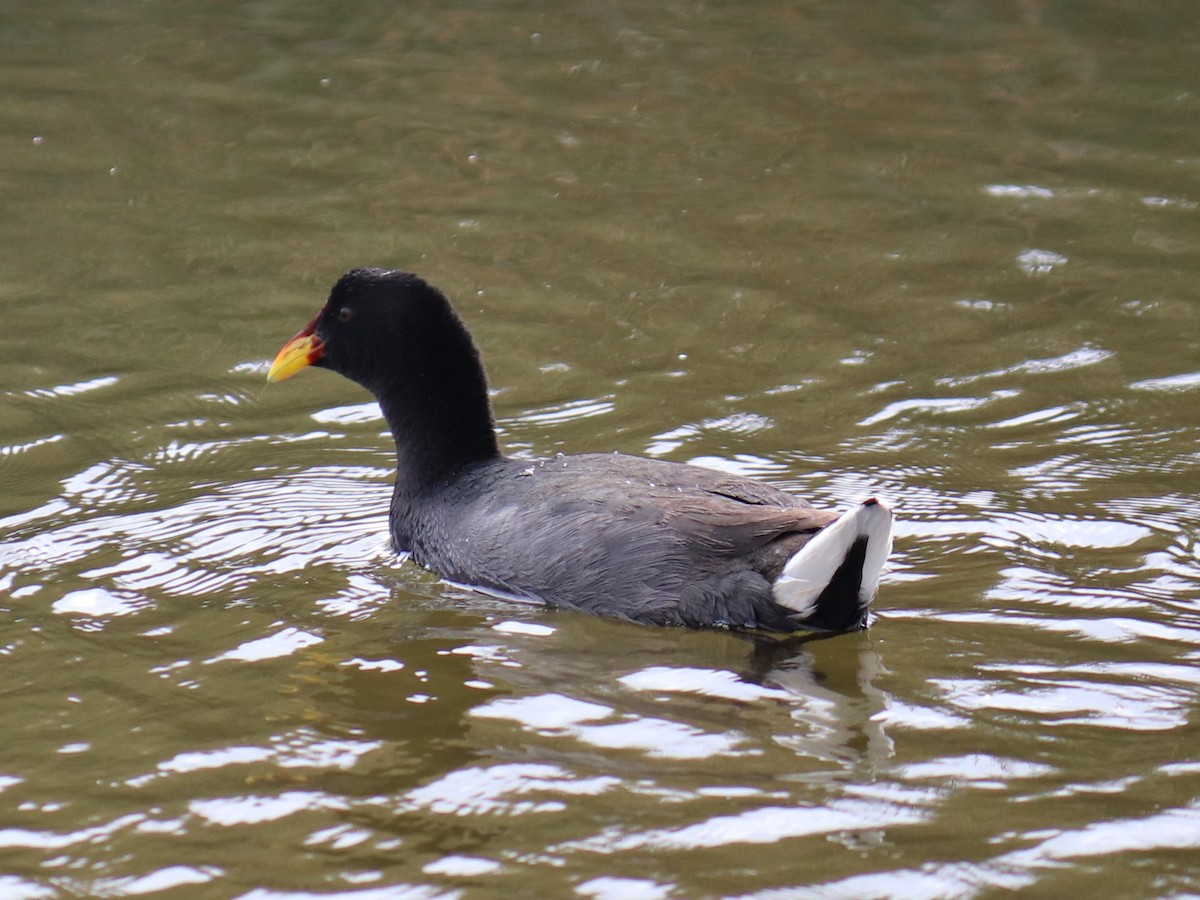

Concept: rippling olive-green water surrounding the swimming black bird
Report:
left=0, top=0, right=1200, bottom=900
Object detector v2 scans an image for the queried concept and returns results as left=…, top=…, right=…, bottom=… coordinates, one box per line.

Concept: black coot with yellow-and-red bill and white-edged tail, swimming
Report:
left=268, top=269, right=892, bottom=631
